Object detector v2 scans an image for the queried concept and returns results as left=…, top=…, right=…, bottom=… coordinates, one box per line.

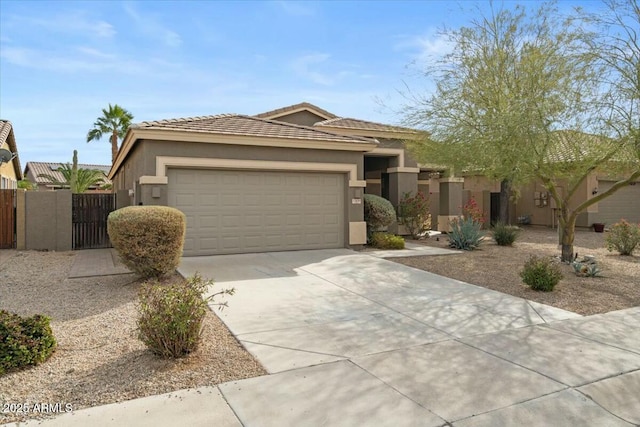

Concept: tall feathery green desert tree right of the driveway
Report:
left=404, top=3, right=629, bottom=260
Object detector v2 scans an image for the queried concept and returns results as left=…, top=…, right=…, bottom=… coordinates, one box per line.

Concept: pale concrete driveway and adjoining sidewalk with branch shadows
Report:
left=180, top=249, right=640, bottom=426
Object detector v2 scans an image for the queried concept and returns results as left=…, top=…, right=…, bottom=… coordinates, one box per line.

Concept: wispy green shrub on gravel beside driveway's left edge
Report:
left=138, top=274, right=234, bottom=358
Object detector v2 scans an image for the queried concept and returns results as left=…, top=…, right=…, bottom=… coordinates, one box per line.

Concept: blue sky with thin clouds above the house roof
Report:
left=0, top=0, right=599, bottom=167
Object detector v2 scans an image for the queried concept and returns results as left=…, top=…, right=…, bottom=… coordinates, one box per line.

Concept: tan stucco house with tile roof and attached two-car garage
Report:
left=109, top=103, right=640, bottom=256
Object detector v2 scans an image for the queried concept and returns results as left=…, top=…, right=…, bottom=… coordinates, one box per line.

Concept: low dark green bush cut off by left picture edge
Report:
left=0, top=310, right=56, bottom=375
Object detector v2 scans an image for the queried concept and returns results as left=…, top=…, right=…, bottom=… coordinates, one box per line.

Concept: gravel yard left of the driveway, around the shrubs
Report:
left=0, top=251, right=266, bottom=424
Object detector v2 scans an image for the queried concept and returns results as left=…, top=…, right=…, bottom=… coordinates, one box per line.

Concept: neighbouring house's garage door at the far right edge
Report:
left=597, top=181, right=640, bottom=226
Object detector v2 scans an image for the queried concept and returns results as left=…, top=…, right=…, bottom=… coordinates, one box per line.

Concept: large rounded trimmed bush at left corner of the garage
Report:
left=107, top=206, right=186, bottom=279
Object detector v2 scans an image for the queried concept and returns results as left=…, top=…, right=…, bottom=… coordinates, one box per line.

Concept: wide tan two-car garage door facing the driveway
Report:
left=168, top=169, right=345, bottom=256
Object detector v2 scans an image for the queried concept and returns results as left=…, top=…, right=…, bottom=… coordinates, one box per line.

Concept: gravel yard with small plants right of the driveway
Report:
left=390, top=227, right=640, bottom=315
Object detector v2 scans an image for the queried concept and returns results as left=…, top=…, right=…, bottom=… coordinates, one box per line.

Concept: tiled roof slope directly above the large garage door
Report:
left=131, top=114, right=374, bottom=144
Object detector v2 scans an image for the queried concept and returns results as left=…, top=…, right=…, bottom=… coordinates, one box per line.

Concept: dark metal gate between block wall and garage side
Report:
left=72, top=194, right=116, bottom=249
